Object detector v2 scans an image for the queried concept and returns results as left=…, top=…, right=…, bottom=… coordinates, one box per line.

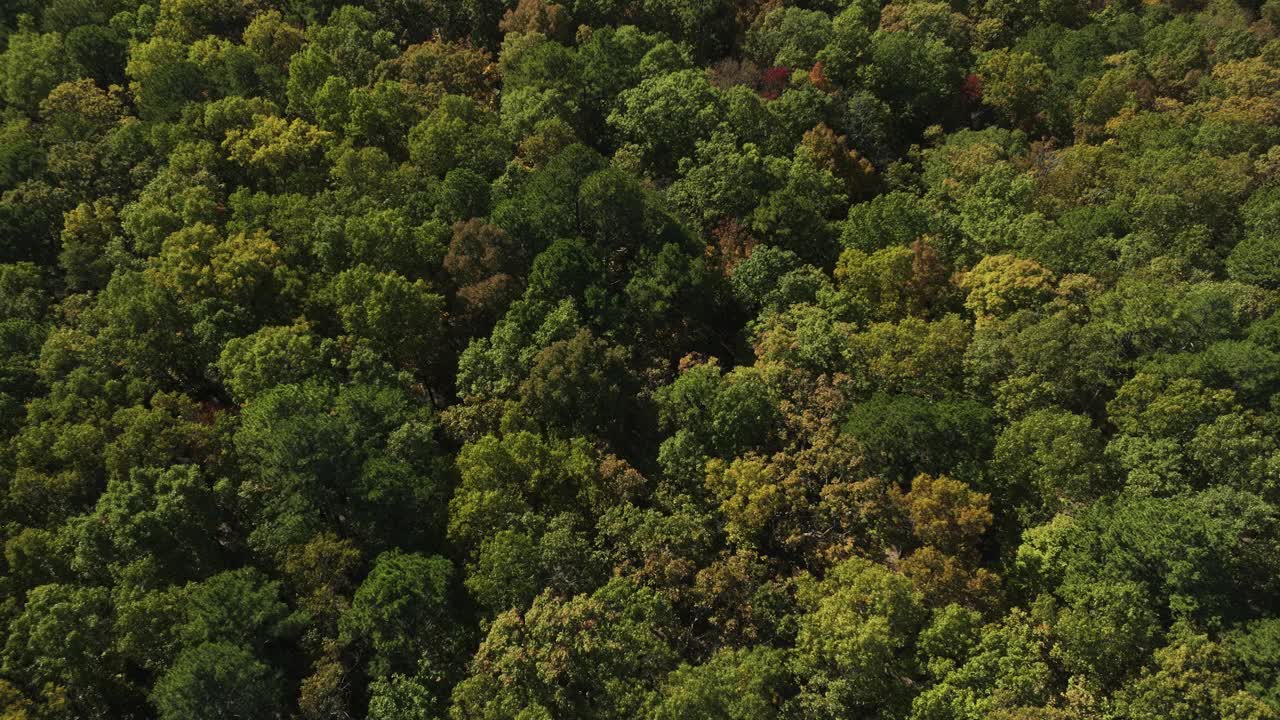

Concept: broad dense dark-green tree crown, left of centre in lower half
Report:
left=234, top=378, right=447, bottom=553
